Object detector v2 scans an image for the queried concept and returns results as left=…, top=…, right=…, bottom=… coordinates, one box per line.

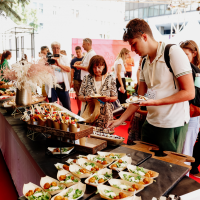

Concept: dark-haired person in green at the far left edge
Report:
left=0, top=51, right=12, bottom=82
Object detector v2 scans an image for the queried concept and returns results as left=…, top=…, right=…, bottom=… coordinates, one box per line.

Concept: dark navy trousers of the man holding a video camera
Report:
left=49, top=88, right=71, bottom=111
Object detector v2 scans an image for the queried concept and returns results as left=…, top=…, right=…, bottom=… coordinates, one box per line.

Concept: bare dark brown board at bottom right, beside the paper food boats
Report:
left=137, top=158, right=189, bottom=200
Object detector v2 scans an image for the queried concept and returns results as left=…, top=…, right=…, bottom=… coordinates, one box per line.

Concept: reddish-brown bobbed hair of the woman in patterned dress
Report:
left=88, top=55, right=108, bottom=76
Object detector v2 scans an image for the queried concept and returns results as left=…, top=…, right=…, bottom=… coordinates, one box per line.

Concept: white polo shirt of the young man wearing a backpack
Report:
left=140, top=43, right=192, bottom=128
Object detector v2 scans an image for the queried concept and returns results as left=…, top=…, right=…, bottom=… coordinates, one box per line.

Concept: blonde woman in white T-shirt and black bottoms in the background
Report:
left=114, top=48, right=130, bottom=104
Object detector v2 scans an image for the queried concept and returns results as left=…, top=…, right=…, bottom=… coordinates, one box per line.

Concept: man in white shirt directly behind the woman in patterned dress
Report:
left=74, top=38, right=96, bottom=80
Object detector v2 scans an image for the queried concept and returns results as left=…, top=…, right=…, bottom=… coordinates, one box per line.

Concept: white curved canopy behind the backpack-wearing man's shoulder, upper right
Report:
left=168, top=20, right=200, bottom=45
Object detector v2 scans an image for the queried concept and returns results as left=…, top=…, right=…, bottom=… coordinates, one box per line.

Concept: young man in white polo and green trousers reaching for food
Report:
left=110, top=19, right=195, bottom=153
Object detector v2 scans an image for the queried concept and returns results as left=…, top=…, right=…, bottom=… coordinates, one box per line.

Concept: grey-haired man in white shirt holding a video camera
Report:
left=48, top=42, right=71, bottom=111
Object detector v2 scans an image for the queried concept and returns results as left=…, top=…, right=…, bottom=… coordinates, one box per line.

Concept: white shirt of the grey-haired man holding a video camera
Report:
left=45, top=54, right=70, bottom=98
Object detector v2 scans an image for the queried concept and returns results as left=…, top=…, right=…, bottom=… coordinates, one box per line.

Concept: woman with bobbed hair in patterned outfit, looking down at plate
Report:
left=79, top=55, right=117, bottom=128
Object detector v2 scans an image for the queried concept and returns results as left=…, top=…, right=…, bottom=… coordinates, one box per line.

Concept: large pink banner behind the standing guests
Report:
left=72, top=38, right=139, bottom=71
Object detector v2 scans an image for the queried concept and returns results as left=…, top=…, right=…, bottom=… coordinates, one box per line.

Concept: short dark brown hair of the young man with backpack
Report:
left=123, top=18, right=154, bottom=42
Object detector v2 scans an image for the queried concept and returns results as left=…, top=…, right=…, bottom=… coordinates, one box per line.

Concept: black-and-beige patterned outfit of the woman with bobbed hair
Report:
left=79, top=74, right=117, bottom=128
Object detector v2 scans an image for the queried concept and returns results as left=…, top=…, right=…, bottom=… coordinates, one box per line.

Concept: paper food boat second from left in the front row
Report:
left=40, top=176, right=66, bottom=195
